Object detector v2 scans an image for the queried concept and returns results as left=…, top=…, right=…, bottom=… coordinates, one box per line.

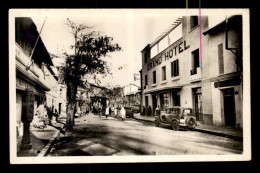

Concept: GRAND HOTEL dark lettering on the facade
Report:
left=147, top=40, right=190, bottom=71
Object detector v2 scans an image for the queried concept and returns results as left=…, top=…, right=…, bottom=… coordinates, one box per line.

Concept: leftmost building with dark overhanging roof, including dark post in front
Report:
left=15, top=17, right=53, bottom=151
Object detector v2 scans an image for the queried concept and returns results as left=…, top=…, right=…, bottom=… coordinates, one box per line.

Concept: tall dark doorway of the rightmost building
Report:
left=223, top=88, right=236, bottom=126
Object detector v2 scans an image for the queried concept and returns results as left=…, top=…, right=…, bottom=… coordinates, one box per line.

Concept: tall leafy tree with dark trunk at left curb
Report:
left=63, top=19, right=121, bottom=135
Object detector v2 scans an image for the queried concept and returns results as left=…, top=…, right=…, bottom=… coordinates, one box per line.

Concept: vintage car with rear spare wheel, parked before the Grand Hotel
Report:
left=155, top=106, right=197, bottom=130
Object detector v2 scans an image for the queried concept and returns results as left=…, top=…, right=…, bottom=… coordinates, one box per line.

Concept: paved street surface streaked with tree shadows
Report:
left=48, top=114, right=243, bottom=156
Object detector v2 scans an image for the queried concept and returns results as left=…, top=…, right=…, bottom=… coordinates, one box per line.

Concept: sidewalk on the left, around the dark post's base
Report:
left=17, top=119, right=64, bottom=157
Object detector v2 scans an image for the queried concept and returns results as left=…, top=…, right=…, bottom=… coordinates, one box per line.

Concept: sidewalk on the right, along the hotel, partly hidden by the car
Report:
left=134, top=113, right=243, bottom=141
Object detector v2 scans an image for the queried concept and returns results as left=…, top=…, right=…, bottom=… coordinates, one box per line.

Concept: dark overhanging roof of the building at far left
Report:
left=15, top=17, right=53, bottom=65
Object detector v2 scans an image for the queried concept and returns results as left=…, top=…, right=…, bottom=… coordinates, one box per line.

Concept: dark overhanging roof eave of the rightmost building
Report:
left=203, top=15, right=242, bottom=35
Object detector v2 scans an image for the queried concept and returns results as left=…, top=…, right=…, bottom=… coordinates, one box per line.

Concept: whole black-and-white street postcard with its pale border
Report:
left=8, top=8, right=251, bottom=164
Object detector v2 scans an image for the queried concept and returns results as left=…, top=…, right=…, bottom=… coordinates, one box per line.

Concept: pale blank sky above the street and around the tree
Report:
left=27, top=9, right=233, bottom=86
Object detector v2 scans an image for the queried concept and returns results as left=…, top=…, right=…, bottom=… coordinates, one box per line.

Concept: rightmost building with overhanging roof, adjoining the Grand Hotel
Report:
left=202, top=15, right=243, bottom=128
